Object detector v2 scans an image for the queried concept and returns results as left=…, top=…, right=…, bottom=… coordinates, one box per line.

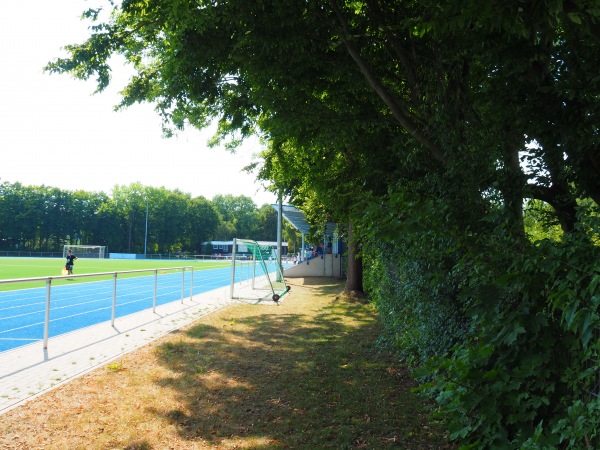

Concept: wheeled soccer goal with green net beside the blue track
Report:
left=231, top=239, right=290, bottom=302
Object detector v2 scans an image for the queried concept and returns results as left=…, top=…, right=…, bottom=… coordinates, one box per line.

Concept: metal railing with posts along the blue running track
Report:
left=0, top=266, right=194, bottom=349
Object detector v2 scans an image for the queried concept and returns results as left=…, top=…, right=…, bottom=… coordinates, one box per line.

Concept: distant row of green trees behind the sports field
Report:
left=0, top=182, right=299, bottom=254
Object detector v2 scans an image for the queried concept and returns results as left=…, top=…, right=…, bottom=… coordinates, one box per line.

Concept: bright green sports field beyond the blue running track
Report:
left=0, top=257, right=231, bottom=290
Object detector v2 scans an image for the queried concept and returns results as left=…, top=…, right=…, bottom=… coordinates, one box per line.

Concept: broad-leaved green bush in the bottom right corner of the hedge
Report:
left=421, top=237, right=600, bottom=449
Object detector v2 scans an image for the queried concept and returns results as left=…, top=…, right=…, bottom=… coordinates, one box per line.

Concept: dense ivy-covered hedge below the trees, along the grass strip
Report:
left=365, top=214, right=600, bottom=449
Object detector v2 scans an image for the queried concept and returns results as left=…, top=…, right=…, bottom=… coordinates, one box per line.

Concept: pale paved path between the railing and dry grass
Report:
left=0, top=286, right=240, bottom=414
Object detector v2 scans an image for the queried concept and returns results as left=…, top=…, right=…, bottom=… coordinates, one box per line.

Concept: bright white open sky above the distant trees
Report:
left=0, top=0, right=275, bottom=206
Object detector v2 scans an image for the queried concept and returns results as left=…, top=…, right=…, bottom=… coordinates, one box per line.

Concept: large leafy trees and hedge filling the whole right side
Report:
left=46, top=0, right=600, bottom=449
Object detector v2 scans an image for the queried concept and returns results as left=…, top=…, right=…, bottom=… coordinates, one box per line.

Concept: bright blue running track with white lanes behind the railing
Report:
left=0, top=268, right=237, bottom=352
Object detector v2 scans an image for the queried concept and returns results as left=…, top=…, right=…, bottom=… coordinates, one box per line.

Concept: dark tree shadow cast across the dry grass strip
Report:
left=151, top=280, right=444, bottom=449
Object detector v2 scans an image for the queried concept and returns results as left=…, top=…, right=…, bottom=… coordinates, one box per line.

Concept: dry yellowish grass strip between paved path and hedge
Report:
left=0, top=278, right=452, bottom=450
